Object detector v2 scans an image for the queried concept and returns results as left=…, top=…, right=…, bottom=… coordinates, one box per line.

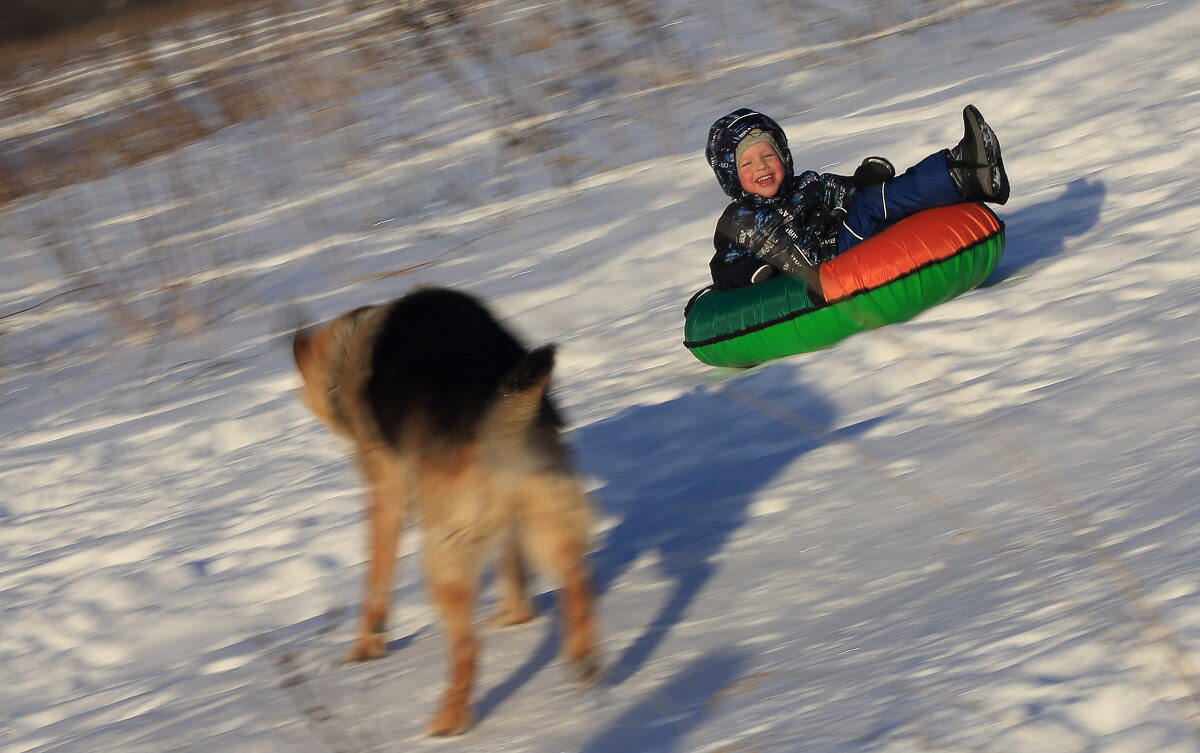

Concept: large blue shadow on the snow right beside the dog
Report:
left=476, top=374, right=865, bottom=719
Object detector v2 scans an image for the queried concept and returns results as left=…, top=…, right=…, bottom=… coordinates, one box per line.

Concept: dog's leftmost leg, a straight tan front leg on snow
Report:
left=344, top=457, right=406, bottom=662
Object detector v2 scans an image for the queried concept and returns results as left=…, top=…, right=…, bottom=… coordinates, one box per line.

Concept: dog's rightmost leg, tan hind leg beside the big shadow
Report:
left=523, top=476, right=600, bottom=683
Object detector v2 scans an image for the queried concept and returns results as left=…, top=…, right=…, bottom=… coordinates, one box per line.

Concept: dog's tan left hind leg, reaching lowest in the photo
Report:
left=425, top=529, right=481, bottom=736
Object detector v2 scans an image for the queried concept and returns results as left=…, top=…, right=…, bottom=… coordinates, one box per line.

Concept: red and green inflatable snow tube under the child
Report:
left=684, top=204, right=1004, bottom=367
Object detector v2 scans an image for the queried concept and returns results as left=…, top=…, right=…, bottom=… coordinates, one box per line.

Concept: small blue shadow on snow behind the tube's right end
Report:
left=980, top=177, right=1108, bottom=288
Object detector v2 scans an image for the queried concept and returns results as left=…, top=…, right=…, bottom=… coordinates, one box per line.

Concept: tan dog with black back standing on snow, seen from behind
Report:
left=293, top=288, right=599, bottom=736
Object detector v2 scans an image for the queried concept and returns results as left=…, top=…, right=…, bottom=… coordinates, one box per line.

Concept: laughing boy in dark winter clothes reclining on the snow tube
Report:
left=704, top=104, right=1009, bottom=300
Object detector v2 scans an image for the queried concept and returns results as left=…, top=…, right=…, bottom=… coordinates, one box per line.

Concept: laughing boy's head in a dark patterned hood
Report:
left=704, top=108, right=792, bottom=200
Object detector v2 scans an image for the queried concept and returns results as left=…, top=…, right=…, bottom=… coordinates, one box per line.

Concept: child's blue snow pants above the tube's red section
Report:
left=838, top=150, right=967, bottom=253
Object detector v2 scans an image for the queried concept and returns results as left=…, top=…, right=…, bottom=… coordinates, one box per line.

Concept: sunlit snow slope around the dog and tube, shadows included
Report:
left=0, top=0, right=1200, bottom=753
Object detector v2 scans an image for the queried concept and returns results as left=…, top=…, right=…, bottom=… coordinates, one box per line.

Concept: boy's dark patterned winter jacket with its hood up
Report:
left=704, top=108, right=856, bottom=295
